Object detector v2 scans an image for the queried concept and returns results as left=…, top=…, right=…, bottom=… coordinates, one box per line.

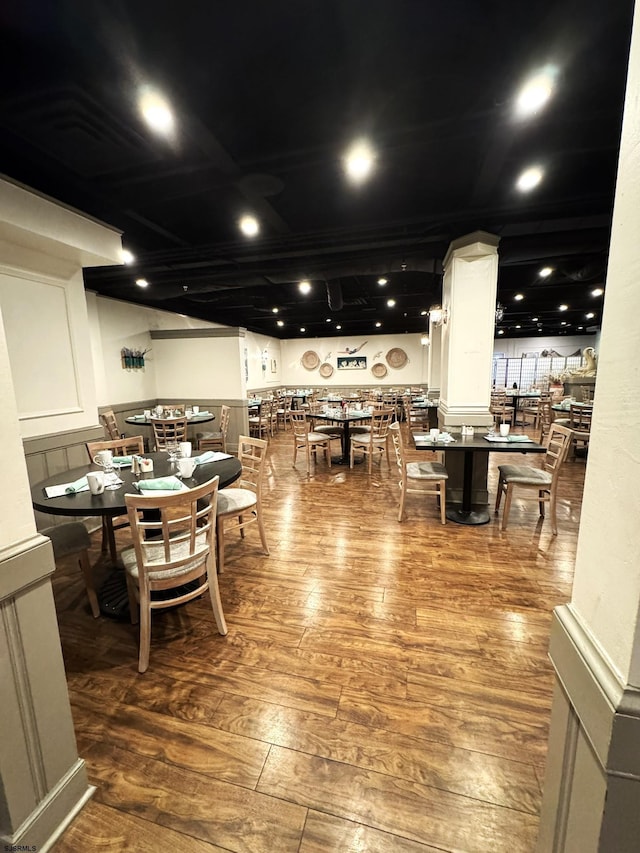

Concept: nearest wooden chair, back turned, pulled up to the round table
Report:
left=120, top=477, right=227, bottom=672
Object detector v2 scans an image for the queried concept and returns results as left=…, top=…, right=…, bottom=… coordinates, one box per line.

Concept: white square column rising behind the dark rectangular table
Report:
left=439, top=231, right=499, bottom=431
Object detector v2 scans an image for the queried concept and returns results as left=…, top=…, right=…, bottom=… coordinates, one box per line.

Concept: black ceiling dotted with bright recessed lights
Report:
left=0, top=0, right=633, bottom=338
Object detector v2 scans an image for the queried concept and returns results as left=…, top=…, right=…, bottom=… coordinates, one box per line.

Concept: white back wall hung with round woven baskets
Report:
left=282, top=334, right=427, bottom=388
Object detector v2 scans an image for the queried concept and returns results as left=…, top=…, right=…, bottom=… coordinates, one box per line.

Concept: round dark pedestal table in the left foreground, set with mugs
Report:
left=31, top=451, right=242, bottom=616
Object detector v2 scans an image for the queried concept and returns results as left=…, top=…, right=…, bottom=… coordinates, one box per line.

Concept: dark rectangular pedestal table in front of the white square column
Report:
left=413, top=433, right=546, bottom=525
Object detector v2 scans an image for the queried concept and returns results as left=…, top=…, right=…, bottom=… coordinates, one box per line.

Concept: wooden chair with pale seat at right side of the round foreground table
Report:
left=216, top=435, right=269, bottom=573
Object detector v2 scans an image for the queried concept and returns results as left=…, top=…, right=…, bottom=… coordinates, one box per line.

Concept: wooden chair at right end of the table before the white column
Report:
left=495, top=423, right=572, bottom=536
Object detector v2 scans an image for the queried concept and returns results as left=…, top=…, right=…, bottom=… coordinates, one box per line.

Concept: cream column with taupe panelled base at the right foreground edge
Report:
left=538, top=6, right=640, bottom=853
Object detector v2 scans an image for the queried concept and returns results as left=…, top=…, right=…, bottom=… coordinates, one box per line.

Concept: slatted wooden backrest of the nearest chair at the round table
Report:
left=124, top=477, right=220, bottom=589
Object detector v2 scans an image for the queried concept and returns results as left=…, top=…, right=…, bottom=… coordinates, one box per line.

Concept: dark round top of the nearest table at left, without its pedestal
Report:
left=31, top=452, right=242, bottom=516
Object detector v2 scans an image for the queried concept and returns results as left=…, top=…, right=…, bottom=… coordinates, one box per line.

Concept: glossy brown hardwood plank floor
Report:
left=54, top=432, right=585, bottom=853
